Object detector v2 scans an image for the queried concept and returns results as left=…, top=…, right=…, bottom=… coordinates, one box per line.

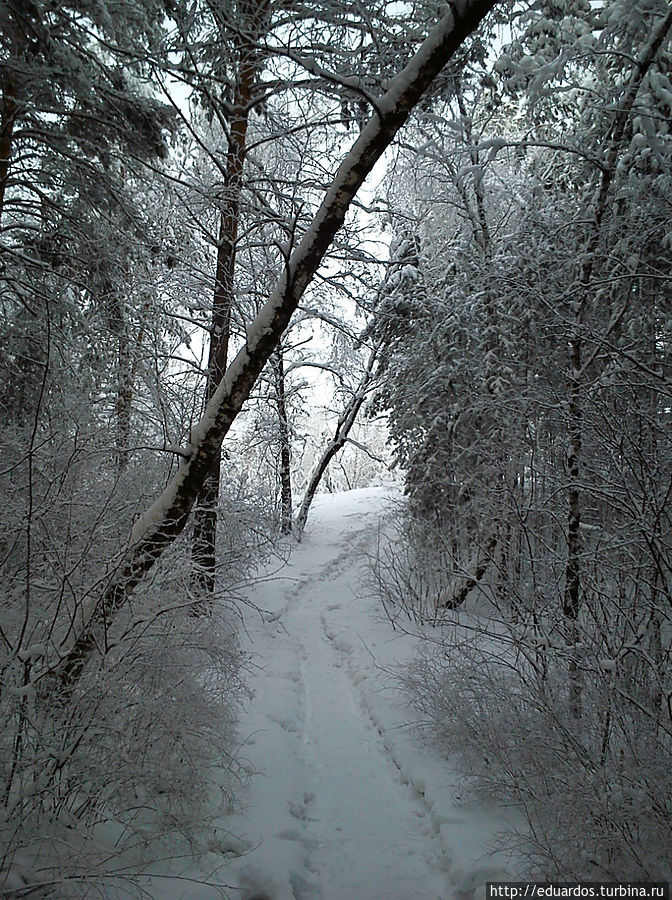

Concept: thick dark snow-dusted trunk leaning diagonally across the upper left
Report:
left=32, top=0, right=496, bottom=695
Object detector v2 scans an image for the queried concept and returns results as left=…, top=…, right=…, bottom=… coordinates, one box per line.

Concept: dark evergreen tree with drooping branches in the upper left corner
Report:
left=0, top=0, right=177, bottom=468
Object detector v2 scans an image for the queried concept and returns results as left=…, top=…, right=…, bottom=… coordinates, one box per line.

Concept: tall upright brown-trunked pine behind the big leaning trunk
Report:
left=175, top=0, right=468, bottom=596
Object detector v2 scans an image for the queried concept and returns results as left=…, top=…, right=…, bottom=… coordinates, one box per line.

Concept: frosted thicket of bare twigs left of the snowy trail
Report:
left=0, top=420, right=267, bottom=898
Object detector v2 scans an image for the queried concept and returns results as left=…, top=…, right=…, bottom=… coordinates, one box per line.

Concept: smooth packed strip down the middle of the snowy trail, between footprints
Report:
left=287, top=564, right=447, bottom=900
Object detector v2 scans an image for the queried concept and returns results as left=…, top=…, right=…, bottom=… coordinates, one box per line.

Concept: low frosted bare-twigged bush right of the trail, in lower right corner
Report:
left=404, top=604, right=672, bottom=880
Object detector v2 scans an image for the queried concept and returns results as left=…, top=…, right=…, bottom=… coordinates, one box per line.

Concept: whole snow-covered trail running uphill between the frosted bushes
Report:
left=220, top=489, right=510, bottom=900
